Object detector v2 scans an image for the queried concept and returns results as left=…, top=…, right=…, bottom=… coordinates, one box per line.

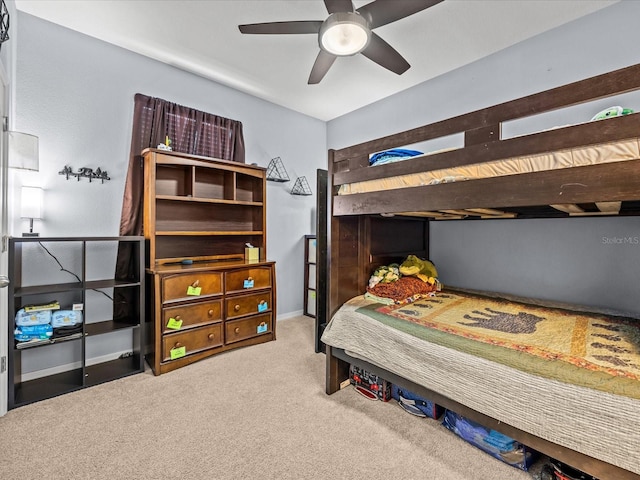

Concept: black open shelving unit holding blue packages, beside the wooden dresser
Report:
left=8, top=237, right=145, bottom=409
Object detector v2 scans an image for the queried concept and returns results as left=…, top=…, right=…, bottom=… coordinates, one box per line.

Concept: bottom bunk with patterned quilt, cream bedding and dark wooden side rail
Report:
left=322, top=289, right=640, bottom=480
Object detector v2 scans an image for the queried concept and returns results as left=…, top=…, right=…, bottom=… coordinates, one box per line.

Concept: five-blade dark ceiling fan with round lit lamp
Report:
left=238, top=0, right=443, bottom=84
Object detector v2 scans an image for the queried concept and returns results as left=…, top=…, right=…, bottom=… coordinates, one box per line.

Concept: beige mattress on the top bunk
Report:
left=338, top=139, right=640, bottom=195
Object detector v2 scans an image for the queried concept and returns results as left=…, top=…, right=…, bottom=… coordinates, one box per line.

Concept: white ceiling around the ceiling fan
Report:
left=15, top=0, right=618, bottom=121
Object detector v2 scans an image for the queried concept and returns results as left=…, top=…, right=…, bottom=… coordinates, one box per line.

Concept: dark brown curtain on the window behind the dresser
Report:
left=114, top=93, right=245, bottom=319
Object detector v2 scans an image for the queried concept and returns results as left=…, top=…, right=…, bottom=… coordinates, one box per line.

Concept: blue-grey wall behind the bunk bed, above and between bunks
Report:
left=327, top=1, right=640, bottom=314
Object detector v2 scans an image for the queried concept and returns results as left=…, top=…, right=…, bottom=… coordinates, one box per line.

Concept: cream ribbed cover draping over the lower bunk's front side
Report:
left=322, top=296, right=640, bottom=474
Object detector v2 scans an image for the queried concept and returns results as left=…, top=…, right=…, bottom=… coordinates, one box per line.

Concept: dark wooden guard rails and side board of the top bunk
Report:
left=329, top=65, right=640, bottom=218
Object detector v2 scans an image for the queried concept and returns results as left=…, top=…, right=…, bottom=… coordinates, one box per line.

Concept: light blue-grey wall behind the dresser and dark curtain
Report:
left=12, top=12, right=326, bottom=316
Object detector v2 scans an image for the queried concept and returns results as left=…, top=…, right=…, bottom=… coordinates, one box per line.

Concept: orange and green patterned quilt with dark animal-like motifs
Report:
left=358, top=292, right=640, bottom=399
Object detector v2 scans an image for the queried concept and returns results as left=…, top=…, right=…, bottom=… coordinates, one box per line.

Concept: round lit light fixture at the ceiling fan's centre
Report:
left=318, top=12, right=371, bottom=57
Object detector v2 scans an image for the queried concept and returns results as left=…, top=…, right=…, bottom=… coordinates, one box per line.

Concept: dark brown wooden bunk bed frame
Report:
left=319, top=65, right=640, bottom=480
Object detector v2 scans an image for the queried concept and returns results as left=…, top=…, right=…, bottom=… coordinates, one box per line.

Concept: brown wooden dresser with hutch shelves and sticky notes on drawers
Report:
left=143, top=149, right=276, bottom=375
